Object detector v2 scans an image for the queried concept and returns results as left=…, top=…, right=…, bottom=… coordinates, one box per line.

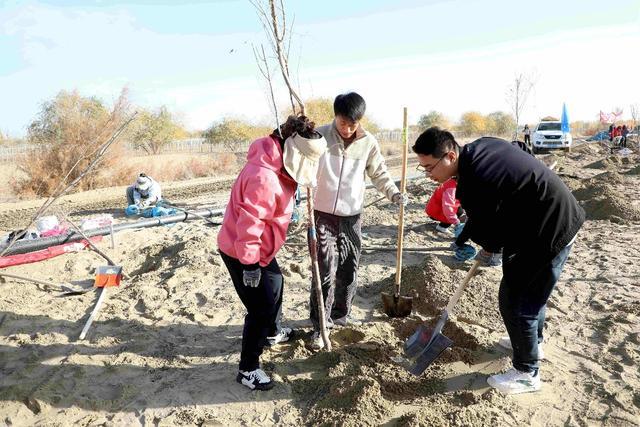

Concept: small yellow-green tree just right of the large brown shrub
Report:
left=131, top=105, right=187, bottom=154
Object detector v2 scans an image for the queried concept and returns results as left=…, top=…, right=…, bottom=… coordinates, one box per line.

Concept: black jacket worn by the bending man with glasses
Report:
left=456, top=137, right=585, bottom=258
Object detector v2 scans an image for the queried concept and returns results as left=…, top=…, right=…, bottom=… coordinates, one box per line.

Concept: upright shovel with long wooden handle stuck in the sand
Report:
left=381, top=107, right=413, bottom=317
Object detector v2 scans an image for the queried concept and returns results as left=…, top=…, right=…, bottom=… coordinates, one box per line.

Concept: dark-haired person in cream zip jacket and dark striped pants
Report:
left=310, top=92, right=408, bottom=349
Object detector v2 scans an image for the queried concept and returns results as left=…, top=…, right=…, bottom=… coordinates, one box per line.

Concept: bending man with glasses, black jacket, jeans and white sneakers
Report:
left=413, top=127, right=585, bottom=394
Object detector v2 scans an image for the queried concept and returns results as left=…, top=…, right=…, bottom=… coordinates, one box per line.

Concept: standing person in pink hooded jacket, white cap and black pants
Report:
left=218, top=116, right=327, bottom=390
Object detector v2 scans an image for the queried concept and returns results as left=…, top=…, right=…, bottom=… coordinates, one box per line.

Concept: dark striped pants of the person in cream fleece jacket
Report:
left=309, top=211, right=362, bottom=331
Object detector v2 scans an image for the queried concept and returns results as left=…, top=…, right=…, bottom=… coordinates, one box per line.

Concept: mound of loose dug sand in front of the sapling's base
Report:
left=268, top=336, right=442, bottom=426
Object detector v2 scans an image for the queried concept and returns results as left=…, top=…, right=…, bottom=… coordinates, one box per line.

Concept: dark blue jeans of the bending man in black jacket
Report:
left=498, top=245, right=572, bottom=372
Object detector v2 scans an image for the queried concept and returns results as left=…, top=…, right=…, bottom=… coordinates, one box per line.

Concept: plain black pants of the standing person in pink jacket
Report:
left=220, top=252, right=284, bottom=371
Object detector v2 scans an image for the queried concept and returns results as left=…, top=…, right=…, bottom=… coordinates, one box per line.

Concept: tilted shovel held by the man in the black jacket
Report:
left=405, top=261, right=480, bottom=376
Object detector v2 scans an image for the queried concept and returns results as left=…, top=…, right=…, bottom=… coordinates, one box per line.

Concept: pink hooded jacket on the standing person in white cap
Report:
left=218, top=136, right=297, bottom=267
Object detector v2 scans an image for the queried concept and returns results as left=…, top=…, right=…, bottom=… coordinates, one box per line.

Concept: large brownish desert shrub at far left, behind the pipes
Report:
left=11, top=91, right=129, bottom=196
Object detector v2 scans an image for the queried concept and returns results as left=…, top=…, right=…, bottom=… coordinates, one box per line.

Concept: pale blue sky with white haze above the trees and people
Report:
left=0, top=0, right=640, bottom=136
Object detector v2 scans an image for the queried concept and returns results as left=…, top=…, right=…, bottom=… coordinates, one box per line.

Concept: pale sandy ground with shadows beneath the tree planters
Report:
left=0, top=144, right=640, bottom=426
